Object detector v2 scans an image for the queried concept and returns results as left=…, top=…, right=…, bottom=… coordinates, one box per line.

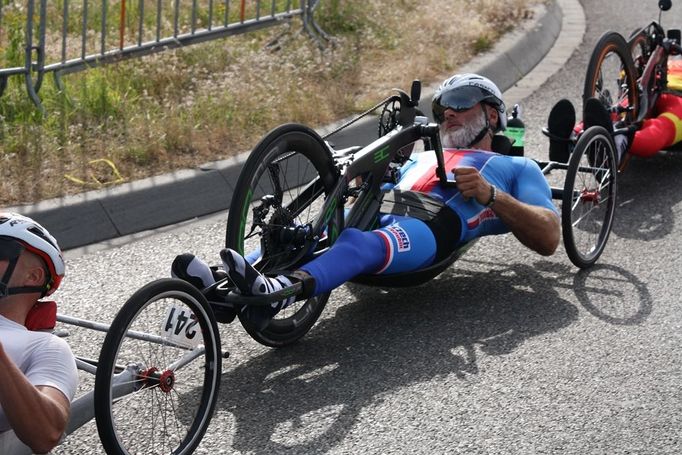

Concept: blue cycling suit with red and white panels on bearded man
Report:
left=301, top=149, right=556, bottom=295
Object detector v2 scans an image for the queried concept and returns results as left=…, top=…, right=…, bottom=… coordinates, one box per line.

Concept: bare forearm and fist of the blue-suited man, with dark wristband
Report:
left=453, top=167, right=561, bottom=256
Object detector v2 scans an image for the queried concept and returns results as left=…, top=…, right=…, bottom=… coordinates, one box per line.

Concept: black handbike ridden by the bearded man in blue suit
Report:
left=197, top=81, right=616, bottom=347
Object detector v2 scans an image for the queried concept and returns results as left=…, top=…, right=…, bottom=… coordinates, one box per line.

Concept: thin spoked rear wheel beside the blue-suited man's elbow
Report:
left=561, top=126, right=618, bottom=269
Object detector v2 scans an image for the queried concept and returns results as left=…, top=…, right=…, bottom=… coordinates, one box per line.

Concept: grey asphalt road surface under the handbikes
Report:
left=55, top=0, right=682, bottom=454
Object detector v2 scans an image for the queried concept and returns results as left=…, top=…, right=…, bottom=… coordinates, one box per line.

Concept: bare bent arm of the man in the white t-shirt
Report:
left=0, top=343, right=70, bottom=453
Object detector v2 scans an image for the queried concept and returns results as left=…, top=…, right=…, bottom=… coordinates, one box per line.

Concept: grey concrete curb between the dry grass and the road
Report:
left=7, top=0, right=584, bottom=250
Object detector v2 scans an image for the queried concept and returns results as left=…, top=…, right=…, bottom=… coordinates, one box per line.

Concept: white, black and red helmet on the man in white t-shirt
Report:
left=0, top=212, right=65, bottom=297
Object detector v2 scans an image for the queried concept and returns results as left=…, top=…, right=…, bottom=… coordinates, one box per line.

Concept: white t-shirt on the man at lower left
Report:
left=0, top=316, right=78, bottom=432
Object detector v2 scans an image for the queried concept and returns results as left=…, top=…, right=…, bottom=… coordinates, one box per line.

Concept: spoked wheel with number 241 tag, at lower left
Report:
left=94, top=278, right=222, bottom=454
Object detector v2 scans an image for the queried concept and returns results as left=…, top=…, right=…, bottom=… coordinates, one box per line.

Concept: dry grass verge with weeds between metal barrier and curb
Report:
left=0, top=0, right=542, bottom=205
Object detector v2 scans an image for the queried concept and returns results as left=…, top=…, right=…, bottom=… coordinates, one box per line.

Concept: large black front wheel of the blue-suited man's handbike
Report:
left=225, top=124, right=343, bottom=347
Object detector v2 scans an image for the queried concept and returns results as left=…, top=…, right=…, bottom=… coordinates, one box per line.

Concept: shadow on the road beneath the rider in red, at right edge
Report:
left=612, top=152, right=682, bottom=241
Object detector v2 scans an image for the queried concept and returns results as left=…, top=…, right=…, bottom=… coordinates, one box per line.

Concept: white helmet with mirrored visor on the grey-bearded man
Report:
left=431, top=73, right=507, bottom=132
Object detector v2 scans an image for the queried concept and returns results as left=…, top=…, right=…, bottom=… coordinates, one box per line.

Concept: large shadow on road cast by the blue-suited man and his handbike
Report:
left=212, top=264, right=578, bottom=453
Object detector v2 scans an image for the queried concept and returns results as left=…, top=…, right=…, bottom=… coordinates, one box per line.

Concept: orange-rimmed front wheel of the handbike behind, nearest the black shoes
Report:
left=583, top=32, right=640, bottom=123
